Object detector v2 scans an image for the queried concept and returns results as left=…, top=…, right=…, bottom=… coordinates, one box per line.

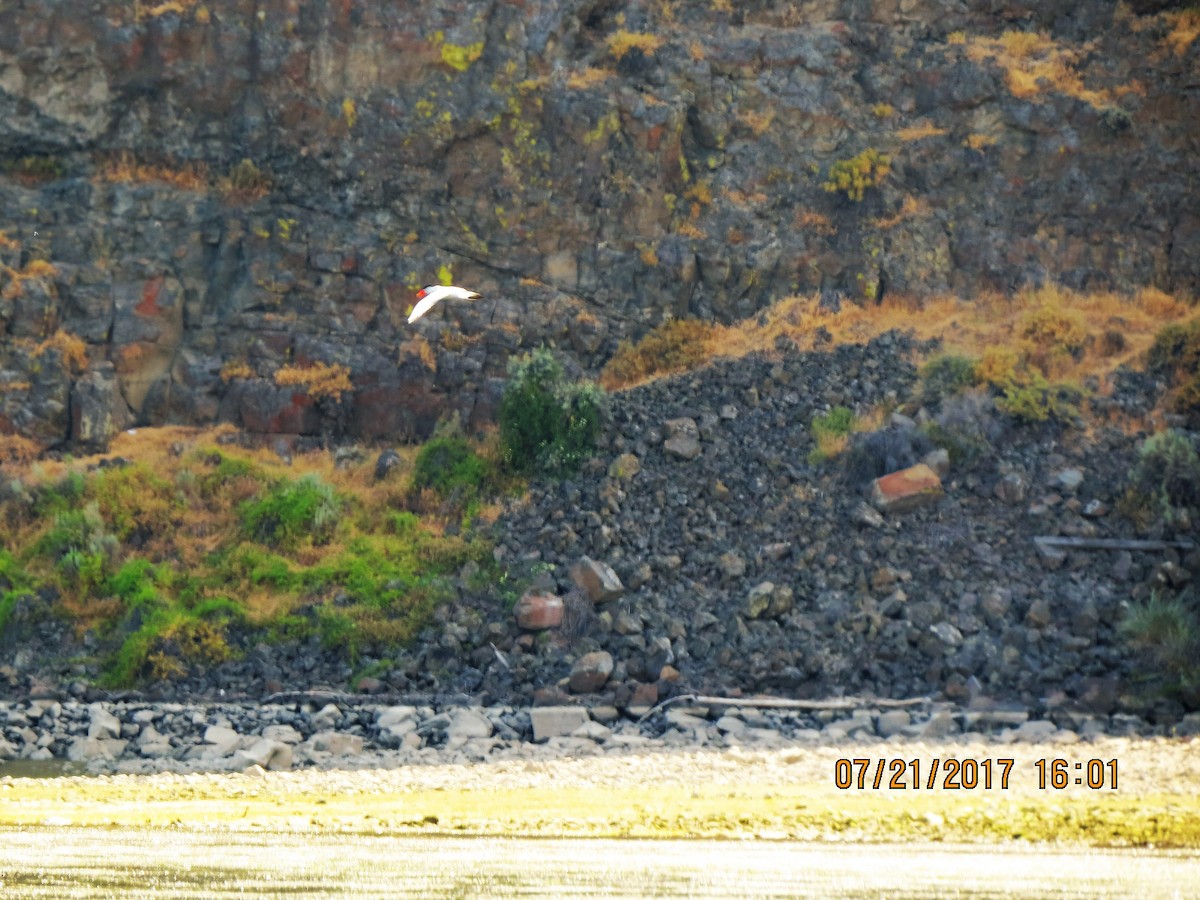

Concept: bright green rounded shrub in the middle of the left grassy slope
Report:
left=239, top=474, right=342, bottom=548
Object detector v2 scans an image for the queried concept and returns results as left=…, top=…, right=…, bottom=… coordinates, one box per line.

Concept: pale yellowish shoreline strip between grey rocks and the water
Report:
left=0, top=738, right=1200, bottom=848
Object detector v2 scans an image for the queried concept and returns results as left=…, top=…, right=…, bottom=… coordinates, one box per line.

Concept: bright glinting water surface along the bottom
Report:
left=0, top=824, right=1200, bottom=900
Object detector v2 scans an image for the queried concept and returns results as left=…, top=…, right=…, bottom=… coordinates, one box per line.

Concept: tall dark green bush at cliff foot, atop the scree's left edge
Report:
left=499, top=349, right=607, bottom=474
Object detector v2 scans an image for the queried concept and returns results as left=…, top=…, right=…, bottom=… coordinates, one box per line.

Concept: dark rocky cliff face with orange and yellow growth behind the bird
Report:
left=0, top=0, right=1200, bottom=448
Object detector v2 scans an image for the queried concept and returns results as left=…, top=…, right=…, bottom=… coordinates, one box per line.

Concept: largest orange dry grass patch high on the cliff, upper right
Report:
left=967, top=31, right=1115, bottom=107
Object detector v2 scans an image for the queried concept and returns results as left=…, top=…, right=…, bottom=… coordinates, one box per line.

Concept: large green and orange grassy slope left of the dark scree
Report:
left=0, top=434, right=496, bottom=688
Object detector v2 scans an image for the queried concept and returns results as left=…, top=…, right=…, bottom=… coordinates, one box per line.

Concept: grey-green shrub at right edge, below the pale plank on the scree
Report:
left=1120, top=593, right=1200, bottom=707
